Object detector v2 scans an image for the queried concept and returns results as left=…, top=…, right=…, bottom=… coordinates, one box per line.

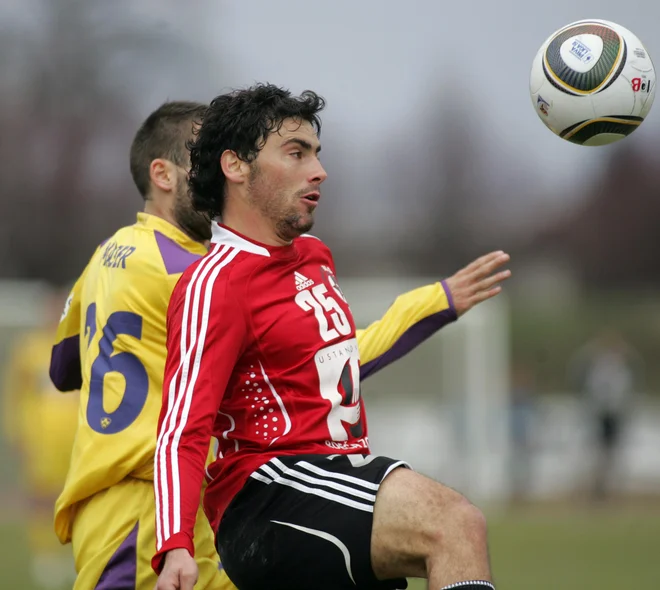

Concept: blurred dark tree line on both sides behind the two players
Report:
left=0, top=0, right=660, bottom=296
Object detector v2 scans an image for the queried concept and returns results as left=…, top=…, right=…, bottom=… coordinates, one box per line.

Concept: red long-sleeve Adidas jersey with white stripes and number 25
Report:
left=153, top=226, right=369, bottom=571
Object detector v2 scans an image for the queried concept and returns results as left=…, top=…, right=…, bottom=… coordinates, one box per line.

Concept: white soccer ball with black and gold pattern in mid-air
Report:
left=529, top=20, right=655, bottom=145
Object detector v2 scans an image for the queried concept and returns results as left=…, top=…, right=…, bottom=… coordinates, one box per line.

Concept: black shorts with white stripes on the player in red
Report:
left=216, top=455, right=408, bottom=590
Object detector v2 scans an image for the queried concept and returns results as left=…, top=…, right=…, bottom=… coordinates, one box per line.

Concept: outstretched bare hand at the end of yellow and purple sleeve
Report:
left=445, top=250, right=511, bottom=317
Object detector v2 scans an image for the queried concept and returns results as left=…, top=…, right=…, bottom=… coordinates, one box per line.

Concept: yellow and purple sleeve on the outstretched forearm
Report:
left=357, top=281, right=457, bottom=379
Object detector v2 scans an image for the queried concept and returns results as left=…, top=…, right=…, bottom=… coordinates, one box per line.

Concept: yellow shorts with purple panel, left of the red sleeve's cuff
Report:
left=71, top=478, right=156, bottom=590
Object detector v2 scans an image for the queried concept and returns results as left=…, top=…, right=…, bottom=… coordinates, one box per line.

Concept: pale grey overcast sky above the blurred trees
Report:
left=3, top=0, right=660, bottom=235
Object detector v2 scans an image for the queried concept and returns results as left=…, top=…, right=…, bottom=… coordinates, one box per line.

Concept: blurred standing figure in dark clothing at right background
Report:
left=569, top=328, right=643, bottom=500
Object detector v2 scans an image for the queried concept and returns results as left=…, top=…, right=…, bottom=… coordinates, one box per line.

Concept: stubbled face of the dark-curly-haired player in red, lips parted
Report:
left=248, top=119, right=327, bottom=241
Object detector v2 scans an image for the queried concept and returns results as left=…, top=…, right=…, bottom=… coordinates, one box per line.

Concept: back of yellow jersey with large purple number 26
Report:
left=50, top=213, right=206, bottom=543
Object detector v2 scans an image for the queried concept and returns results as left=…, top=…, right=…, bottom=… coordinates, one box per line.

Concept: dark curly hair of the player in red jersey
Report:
left=188, top=84, right=325, bottom=217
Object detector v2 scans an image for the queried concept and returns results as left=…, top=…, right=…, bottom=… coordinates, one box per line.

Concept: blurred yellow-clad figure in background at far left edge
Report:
left=2, top=290, right=78, bottom=588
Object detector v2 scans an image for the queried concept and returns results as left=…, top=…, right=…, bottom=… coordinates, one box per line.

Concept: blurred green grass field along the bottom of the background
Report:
left=0, top=504, right=660, bottom=590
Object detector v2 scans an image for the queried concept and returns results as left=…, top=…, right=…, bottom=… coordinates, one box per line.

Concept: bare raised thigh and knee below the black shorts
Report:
left=371, top=469, right=486, bottom=579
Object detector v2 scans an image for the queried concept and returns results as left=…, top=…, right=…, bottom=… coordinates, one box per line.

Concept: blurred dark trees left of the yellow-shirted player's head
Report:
left=0, top=0, right=206, bottom=285
